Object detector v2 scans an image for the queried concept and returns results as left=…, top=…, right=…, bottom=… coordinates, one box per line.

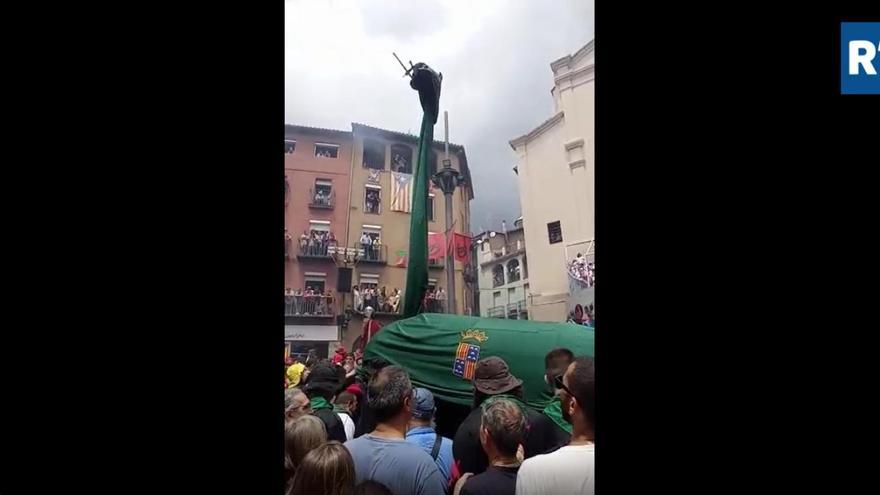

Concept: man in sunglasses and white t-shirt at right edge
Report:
left=516, top=356, right=596, bottom=495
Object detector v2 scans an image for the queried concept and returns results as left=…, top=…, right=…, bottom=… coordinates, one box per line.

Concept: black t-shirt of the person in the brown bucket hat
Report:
left=452, top=407, right=553, bottom=474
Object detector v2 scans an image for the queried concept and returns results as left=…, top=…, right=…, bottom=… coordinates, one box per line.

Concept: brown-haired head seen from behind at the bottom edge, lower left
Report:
left=287, top=441, right=355, bottom=495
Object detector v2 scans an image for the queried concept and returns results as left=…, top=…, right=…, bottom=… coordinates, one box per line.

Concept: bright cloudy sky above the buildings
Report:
left=284, top=0, right=594, bottom=232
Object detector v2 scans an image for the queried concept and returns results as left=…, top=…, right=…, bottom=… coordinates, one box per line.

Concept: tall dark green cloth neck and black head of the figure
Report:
left=403, top=62, right=443, bottom=318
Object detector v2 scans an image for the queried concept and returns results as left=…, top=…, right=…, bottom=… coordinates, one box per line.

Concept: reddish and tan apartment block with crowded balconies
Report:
left=284, top=123, right=474, bottom=356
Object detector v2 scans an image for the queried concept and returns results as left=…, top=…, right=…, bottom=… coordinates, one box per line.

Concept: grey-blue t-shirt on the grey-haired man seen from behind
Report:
left=345, top=434, right=446, bottom=495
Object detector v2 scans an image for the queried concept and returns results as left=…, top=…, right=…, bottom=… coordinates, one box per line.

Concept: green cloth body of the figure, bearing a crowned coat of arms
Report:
left=364, top=313, right=595, bottom=411
